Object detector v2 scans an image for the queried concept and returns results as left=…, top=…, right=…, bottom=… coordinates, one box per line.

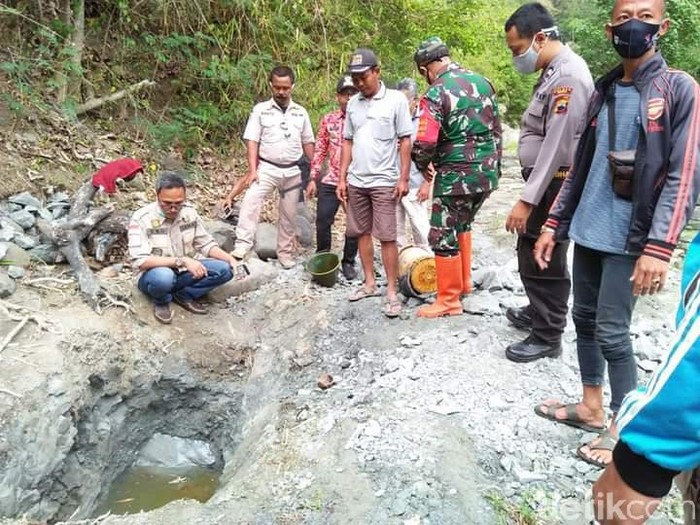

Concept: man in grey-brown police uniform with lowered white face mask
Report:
left=505, top=3, right=593, bottom=362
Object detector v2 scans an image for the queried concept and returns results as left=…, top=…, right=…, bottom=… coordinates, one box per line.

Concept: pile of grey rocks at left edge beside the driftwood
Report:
left=0, top=192, right=71, bottom=298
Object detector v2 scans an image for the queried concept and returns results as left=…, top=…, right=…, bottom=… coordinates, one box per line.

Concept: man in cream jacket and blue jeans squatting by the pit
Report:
left=129, top=172, right=243, bottom=324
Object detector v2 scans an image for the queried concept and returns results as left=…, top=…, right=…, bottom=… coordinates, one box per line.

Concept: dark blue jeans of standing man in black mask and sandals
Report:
left=571, top=244, right=637, bottom=413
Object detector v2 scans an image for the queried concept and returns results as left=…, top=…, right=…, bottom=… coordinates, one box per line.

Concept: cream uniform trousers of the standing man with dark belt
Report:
left=234, top=163, right=301, bottom=259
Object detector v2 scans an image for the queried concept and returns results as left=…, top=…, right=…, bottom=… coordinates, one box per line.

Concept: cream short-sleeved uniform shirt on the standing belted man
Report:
left=243, top=99, right=314, bottom=175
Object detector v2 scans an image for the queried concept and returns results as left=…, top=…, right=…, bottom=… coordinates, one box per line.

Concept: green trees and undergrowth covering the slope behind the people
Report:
left=0, top=0, right=700, bottom=156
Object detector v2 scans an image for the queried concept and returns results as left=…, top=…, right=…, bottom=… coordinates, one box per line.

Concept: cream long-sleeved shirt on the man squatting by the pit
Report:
left=129, top=202, right=218, bottom=276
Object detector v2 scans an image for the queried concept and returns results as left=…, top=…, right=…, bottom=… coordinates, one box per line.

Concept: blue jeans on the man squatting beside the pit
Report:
left=138, top=259, right=233, bottom=304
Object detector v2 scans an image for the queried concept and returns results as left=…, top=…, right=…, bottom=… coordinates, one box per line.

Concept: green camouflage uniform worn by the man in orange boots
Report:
left=411, top=63, right=501, bottom=254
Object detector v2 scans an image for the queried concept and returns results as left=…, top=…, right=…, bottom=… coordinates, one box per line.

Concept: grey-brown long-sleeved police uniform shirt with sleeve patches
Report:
left=518, top=46, right=593, bottom=205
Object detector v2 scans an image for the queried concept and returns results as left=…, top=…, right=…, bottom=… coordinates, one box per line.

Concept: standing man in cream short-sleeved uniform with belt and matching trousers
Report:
left=232, top=66, right=314, bottom=268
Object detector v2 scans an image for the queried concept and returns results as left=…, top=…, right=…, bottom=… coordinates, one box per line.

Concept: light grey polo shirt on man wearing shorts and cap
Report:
left=344, top=82, right=413, bottom=188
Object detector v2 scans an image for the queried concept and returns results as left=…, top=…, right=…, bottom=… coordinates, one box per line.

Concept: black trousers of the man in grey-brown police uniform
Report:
left=518, top=180, right=571, bottom=344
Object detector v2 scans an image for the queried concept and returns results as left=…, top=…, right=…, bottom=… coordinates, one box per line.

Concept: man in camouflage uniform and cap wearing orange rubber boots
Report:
left=411, top=37, right=501, bottom=317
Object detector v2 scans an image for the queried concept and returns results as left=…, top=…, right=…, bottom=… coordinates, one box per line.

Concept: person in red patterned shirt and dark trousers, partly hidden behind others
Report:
left=306, top=75, right=357, bottom=281
